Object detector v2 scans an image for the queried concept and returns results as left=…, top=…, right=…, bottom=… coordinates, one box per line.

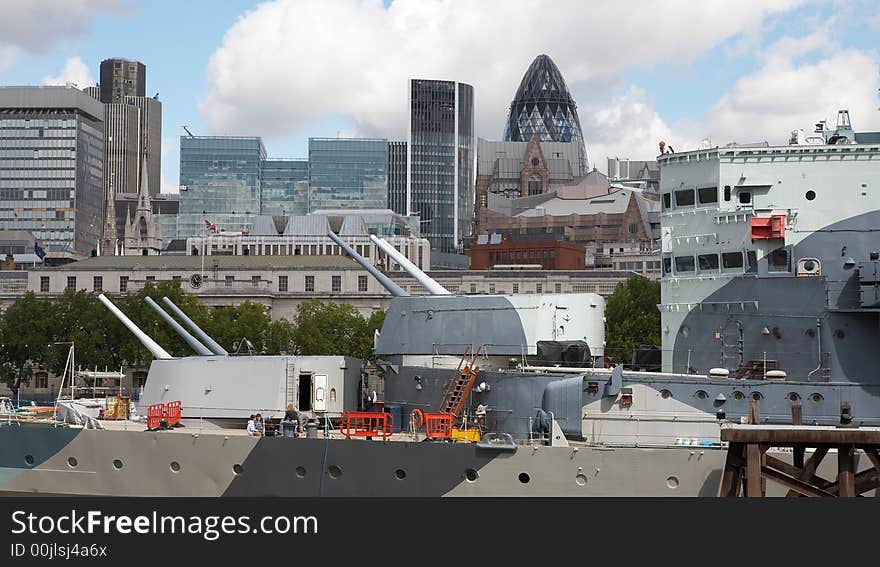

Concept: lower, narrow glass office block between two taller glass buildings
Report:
left=260, top=159, right=309, bottom=216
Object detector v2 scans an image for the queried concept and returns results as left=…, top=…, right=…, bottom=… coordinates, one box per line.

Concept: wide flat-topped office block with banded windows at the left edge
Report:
left=0, top=87, right=105, bottom=263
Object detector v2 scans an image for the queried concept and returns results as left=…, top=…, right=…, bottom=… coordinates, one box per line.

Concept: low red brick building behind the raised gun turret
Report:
left=471, top=240, right=587, bottom=270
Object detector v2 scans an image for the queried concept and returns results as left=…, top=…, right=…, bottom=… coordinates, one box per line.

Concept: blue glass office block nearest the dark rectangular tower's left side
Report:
left=308, top=138, right=388, bottom=212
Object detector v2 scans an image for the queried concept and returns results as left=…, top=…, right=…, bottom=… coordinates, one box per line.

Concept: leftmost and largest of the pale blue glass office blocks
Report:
left=177, top=136, right=266, bottom=238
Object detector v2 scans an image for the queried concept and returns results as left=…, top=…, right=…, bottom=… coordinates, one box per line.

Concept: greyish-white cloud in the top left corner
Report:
left=0, top=0, right=132, bottom=73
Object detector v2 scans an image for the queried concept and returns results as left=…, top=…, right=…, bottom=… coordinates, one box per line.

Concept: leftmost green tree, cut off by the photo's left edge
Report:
left=0, top=291, right=55, bottom=384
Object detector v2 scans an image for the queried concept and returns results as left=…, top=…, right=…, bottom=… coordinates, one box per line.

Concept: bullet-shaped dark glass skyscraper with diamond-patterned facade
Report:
left=504, top=55, right=587, bottom=175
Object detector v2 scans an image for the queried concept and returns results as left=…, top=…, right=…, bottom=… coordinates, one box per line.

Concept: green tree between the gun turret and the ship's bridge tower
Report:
left=605, top=276, right=660, bottom=363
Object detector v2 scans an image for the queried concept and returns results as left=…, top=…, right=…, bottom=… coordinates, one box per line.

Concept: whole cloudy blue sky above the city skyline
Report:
left=0, top=0, right=880, bottom=192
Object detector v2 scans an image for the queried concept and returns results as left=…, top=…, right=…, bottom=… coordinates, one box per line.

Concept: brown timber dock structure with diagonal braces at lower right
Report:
left=719, top=424, right=880, bottom=497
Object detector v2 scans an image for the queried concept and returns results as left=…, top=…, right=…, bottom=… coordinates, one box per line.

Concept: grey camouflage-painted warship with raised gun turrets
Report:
left=0, top=111, right=880, bottom=496
